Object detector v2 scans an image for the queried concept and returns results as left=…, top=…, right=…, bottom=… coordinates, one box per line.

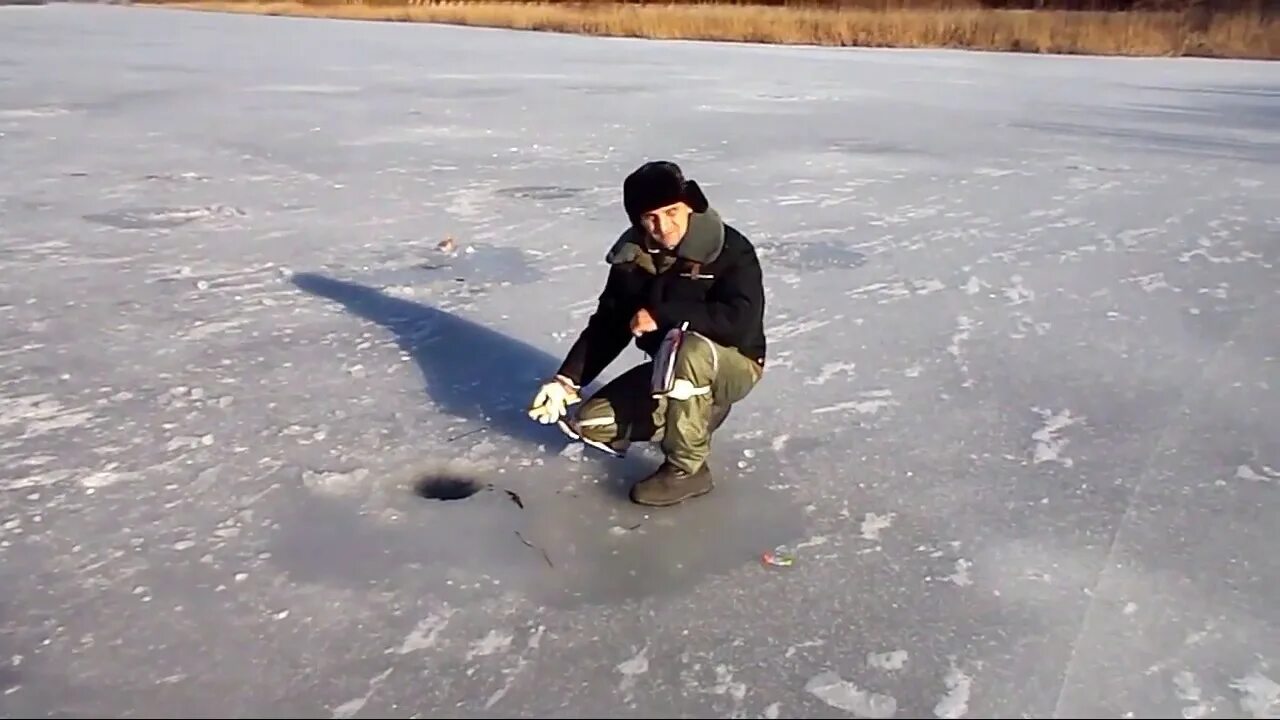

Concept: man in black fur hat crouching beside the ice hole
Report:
left=529, top=161, right=765, bottom=506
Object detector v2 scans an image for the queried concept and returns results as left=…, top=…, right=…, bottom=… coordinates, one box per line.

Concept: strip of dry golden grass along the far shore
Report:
left=142, top=0, right=1280, bottom=59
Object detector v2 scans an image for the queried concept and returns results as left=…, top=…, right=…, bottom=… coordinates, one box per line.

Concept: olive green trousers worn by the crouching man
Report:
left=572, top=332, right=764, bottom=473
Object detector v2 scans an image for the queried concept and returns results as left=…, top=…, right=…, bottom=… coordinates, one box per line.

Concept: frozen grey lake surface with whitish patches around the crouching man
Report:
left=0, top=5, right=1280, bottom=717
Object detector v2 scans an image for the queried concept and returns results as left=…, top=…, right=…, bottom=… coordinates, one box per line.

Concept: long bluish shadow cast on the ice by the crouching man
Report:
left=293, top=273, right=634, bottom=484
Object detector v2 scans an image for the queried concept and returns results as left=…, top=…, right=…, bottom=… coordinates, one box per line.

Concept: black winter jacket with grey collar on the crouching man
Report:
left=559, top=208, right=765, bottom=387
